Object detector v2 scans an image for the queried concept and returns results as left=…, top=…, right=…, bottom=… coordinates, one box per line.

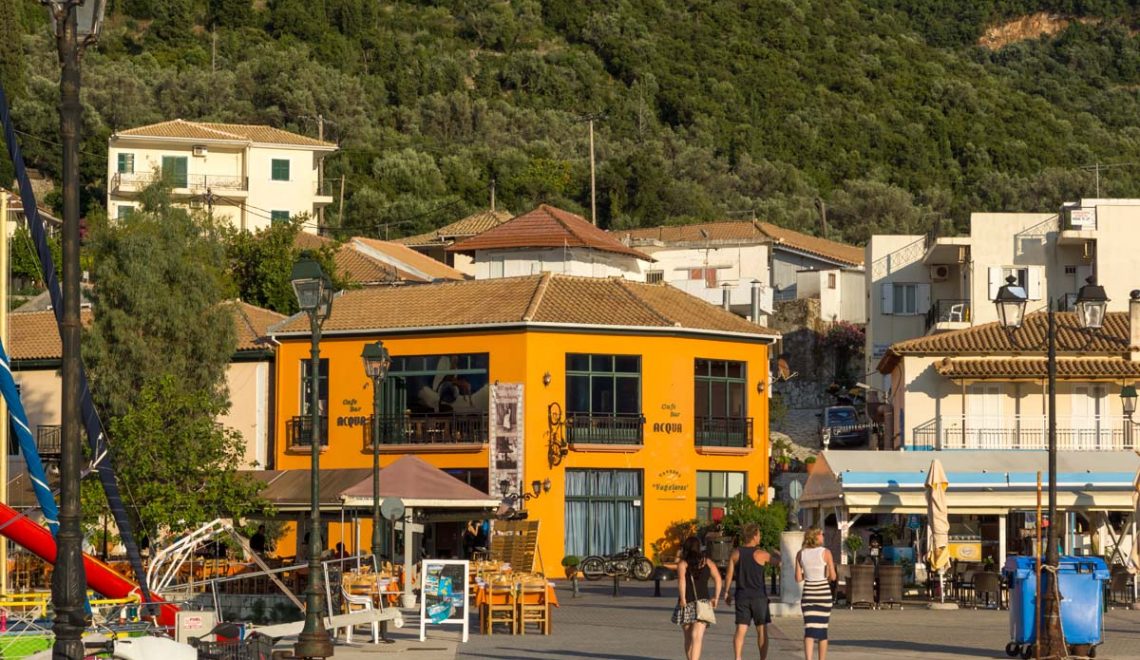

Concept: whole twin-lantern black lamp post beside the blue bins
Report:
left=994, top=277, right=1108, bottom=658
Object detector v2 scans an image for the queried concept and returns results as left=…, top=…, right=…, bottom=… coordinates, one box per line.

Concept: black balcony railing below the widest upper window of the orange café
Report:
left=361, top=413, right=488, bottom=453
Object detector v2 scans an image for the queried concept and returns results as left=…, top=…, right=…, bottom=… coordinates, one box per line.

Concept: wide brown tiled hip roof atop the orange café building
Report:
left=272, top=272, right=779, bottom=337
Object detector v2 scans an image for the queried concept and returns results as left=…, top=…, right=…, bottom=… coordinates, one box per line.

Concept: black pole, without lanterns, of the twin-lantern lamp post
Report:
left=1037, top=299, right=1068, bottom=658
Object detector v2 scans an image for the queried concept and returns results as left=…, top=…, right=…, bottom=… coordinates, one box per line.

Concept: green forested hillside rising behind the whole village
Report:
left=0, top=0, right=1140, bottom=242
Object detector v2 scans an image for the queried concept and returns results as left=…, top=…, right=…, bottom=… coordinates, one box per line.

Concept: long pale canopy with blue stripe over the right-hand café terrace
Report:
left=799, top=450, right=1140, bottom=514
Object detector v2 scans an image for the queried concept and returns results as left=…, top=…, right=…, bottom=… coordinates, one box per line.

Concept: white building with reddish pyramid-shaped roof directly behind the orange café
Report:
left=447, top=204, right=653, bottom=282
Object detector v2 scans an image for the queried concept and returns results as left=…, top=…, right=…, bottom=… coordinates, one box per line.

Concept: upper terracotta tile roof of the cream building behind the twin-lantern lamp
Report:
left=879, top=311, right=1131, bottom=374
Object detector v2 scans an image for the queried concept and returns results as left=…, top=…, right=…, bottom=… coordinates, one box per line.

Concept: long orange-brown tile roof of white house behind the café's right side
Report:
left=618, top=220, right=863, bottom=266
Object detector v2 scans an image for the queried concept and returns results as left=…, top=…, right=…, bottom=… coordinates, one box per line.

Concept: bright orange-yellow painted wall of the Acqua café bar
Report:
left=276, top=331, right=768, bottom=573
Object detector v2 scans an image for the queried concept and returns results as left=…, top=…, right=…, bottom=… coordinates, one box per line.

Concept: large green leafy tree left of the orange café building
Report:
left=83, top=186, right=261, bottom=532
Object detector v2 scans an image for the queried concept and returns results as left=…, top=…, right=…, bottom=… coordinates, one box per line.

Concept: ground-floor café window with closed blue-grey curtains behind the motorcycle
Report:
left=565, top=470, right=643, bottom=557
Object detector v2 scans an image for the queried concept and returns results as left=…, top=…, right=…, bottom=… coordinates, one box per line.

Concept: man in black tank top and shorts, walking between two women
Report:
left=725, top=523, right=780, bottom=660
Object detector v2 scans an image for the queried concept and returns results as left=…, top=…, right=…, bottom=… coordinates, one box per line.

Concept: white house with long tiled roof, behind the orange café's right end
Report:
left=617, top=220, right=865, bottom=324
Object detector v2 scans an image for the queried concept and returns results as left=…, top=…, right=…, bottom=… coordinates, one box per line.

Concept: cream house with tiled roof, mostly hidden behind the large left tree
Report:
left=8, top=302, right=285, bottom=474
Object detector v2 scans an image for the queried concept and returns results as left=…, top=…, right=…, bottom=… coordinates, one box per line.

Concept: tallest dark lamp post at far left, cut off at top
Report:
left=43, top=0, right=104, bottom=660
